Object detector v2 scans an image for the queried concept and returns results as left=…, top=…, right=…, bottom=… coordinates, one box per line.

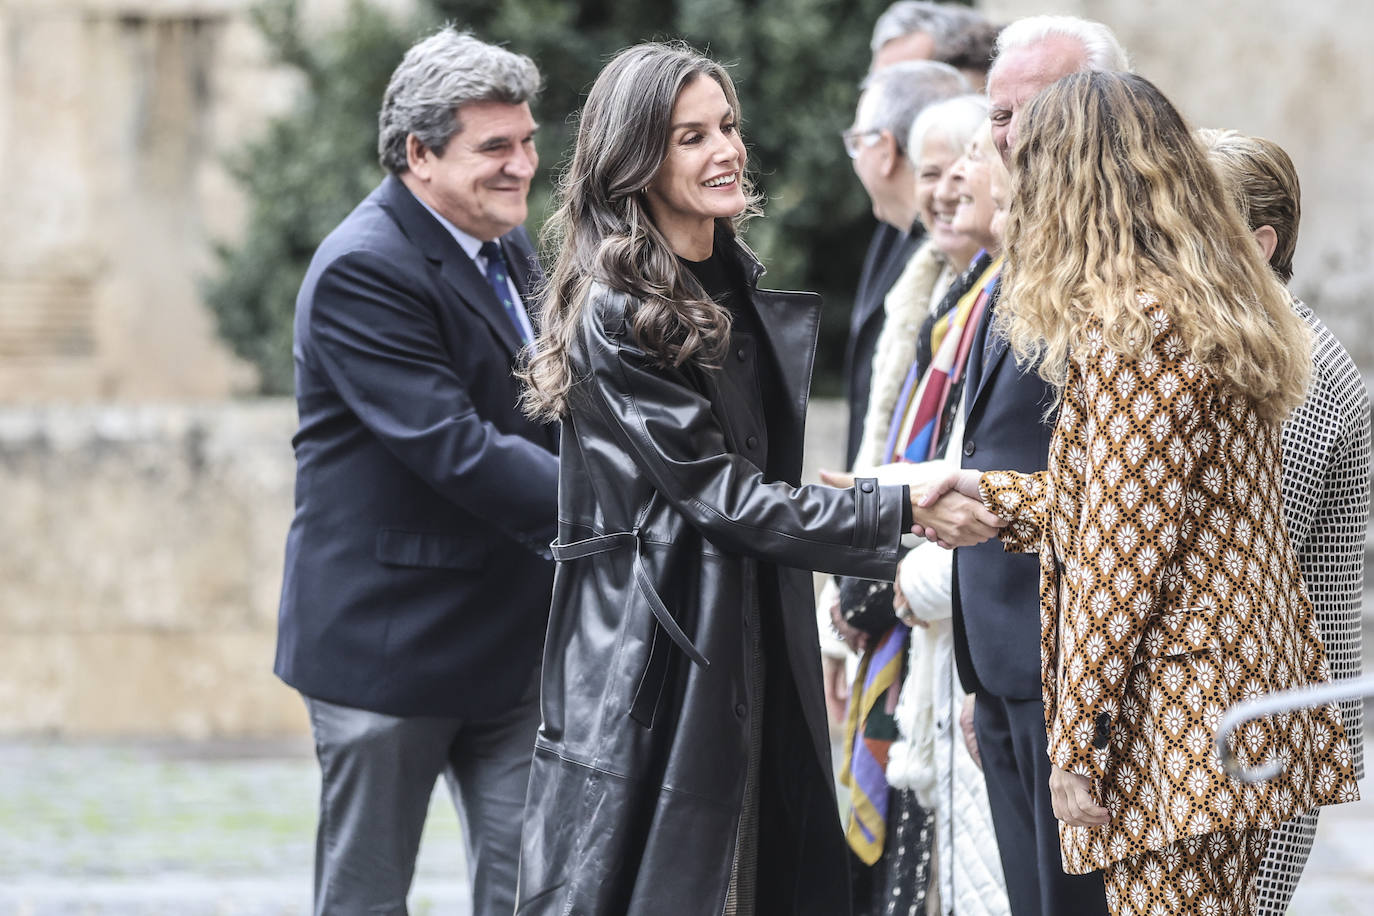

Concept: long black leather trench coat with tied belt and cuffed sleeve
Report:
left=517, top=242, right=903, bottom=916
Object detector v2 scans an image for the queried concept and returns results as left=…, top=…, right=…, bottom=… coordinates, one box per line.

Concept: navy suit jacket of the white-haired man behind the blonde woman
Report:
left=952, top=287, right=1054, bottom=699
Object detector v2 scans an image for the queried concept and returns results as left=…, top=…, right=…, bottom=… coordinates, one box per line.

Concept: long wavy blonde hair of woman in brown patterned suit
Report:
left=999, top=71, right=1311, bottom=420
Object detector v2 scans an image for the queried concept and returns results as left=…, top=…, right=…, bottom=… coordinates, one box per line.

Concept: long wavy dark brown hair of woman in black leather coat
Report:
left=521, top=43, right=757, bottom=420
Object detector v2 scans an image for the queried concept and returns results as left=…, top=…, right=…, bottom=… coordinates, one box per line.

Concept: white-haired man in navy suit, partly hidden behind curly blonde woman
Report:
left=954, top=16, right=1128, bottom=916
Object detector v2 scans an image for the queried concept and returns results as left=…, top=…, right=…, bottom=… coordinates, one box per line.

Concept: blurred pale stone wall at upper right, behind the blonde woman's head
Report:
left=977, top=0, right=1374, bottom=378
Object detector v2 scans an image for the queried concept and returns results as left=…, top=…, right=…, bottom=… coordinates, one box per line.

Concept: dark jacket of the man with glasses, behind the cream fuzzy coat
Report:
left=845, top=222, right=926, bottom=467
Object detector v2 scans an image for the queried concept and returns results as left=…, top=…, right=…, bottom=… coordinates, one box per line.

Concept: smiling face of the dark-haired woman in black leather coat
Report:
left=644, top=76, right=746, bottom=260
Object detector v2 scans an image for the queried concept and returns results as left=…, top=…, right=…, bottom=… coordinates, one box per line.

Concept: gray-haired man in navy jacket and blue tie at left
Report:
left=276, top=29, right=556, bottom=916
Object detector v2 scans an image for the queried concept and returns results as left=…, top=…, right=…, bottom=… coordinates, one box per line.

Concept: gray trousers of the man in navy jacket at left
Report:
left=305, top=676, right=539, bottom=916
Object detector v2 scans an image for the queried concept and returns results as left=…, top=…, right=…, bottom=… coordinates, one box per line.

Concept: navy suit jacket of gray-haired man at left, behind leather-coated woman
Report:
left=276, top=171, right=558, bottom=717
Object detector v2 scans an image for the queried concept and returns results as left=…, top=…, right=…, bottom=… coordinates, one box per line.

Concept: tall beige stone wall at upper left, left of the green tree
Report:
left=0, top=0, right=408, bottom=404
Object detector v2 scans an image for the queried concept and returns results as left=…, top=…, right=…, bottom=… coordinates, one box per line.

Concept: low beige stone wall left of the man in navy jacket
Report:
left=0, top=401, right=305, bottom=737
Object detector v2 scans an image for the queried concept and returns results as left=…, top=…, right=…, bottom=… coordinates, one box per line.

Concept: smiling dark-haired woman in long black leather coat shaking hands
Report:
left=517, top=44, right=991, bottom=916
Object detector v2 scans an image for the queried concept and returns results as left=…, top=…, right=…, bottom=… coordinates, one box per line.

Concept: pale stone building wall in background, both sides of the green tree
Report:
left=0, top=0, right=1374, bottom=404
